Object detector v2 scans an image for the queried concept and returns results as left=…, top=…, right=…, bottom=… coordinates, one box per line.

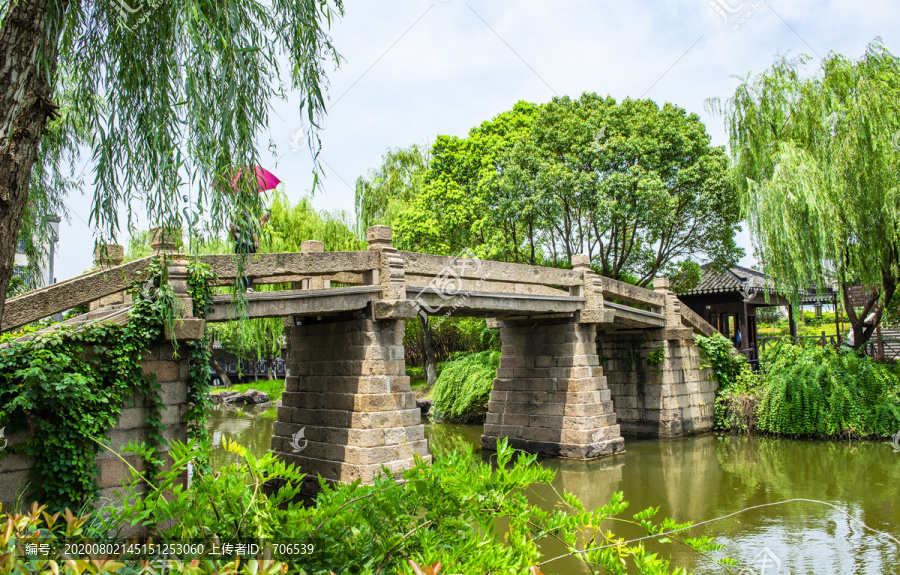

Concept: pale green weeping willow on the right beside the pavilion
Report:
left=708, top=40, right=900, bottom=348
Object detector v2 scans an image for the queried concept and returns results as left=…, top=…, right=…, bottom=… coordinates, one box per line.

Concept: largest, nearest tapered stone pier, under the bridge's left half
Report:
left=272, top=319, right=430, bottom=491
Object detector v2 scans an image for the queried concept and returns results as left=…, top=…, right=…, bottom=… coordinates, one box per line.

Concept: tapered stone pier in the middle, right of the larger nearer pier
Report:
left=481, top=320, right=624, bottom=459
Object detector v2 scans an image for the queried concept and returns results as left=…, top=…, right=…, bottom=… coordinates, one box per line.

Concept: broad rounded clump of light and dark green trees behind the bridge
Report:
left=400, top=94, right=743, bottom=285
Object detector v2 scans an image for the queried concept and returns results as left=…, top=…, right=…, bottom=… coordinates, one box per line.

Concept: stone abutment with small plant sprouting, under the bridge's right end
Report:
left=597, top=328, right=717, bottom=437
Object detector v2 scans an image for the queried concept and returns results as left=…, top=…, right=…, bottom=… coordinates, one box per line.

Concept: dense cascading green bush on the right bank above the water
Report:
left=757, top=341, right=900, bottom=437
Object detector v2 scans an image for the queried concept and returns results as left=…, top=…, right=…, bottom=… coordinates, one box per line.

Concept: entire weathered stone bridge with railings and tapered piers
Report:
left=2, top=226, right=715, bottom=490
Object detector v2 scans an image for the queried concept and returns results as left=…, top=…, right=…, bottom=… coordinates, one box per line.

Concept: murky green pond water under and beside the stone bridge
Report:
left=210, top=408, right=900, bottom=575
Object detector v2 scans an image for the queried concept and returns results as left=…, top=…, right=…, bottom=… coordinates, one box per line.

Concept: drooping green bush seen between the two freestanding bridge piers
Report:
left=431, top=351, right=500, bottom=423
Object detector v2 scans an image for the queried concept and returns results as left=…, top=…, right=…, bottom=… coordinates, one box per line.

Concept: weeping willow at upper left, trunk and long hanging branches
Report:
left=0, top=0, right=343, bottom=324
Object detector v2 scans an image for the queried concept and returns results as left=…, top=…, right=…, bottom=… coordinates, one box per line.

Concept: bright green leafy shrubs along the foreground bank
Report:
left=0, top=439, right=734, bottom=575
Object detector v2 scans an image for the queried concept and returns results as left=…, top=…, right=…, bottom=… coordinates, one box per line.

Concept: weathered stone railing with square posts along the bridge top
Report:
left=2, top=226, right=711, bottom=331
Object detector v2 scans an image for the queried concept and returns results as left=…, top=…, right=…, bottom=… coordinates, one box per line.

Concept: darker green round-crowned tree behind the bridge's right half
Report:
left=510, top=94, right=743, bottom=285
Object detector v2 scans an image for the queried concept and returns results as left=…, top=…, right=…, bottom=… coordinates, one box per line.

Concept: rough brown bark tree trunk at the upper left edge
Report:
left=0, top=0, right=68, bottom=324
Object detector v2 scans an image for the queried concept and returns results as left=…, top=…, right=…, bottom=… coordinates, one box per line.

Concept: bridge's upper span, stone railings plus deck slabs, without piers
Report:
left=0, top=226, right=715, bottom=335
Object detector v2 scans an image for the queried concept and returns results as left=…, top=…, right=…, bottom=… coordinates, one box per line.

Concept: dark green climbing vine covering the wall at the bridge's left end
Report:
left=0, top=259, right=211, bottom=509
